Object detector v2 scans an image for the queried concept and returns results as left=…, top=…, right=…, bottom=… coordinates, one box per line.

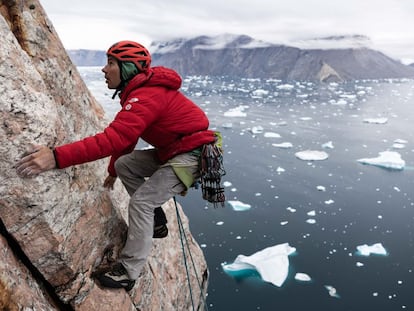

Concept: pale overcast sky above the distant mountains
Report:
left=40, top=0, right=414, bottom=63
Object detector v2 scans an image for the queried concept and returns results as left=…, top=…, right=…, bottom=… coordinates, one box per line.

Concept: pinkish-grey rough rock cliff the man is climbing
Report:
left=0, top=0, right=208, bottom=311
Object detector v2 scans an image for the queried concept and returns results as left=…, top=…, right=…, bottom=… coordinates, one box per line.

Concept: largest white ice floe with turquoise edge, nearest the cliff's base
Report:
left=221, top=243, right=296, bottom=287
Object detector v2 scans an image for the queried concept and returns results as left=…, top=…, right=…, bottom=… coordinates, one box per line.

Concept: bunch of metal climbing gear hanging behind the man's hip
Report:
left=200, top=143, right=226, bottom=207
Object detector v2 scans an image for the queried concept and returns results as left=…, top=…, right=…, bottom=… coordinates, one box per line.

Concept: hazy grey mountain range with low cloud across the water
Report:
left=69, top=35, right=414, bottom=81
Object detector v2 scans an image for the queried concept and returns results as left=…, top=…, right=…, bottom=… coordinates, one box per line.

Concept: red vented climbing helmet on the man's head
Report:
left=106, top=41, right=151, bottom=71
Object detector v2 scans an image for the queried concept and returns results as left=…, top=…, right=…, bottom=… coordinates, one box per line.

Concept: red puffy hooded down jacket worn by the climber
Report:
left=54, top=67, right=215, bottom=176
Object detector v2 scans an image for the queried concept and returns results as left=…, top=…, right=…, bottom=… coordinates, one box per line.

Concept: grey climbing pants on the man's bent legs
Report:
left=115, top=149, right=198, bottom=280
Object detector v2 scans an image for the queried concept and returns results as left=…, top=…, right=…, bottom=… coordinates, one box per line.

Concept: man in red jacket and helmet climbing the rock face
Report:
left=16, top=41, right=216, bottom=290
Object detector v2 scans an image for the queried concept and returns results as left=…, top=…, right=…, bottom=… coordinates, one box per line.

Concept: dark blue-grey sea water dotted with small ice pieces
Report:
left=79, top=67, right=414, bottom=311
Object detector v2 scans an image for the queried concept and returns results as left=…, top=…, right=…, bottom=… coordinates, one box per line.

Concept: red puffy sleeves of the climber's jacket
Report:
left=55, top=96, right=157, bottom=172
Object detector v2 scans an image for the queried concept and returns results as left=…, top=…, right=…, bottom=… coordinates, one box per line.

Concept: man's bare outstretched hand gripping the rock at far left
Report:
left=15, top=146, right=56, bottom=177
